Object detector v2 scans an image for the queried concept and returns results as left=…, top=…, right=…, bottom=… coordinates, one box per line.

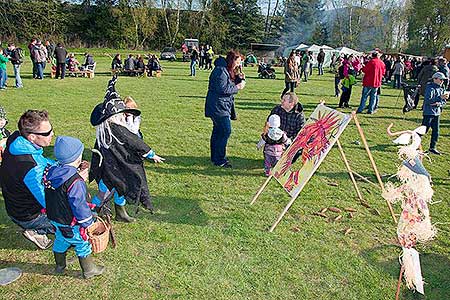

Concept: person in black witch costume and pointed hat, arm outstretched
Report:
left=89, top=74, right=164, bottom=223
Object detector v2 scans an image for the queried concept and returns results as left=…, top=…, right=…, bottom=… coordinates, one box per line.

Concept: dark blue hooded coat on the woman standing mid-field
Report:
left=205, top=57, right=238, bottom=118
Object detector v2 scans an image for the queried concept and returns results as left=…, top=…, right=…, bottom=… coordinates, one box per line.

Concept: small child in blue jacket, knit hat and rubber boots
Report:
left=43, top=136, right=104, bottom=279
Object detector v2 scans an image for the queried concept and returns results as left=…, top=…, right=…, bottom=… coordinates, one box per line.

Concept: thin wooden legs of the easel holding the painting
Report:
left=250, top=112, right=397, bottom=232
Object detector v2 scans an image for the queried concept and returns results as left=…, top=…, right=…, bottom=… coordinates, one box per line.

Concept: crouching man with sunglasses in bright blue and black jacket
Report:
left=0, top=110, right=55, bottom=249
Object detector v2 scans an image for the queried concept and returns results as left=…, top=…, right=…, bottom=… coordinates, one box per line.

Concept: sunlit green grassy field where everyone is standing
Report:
left=0, top=51, right=450, bottom=300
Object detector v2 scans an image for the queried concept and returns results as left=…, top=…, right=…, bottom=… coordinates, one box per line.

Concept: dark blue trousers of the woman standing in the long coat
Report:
left=210, top=116, right=231, bottom=166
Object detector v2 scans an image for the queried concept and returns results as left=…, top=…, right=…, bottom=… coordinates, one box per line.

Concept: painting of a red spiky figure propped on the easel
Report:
left=272, top=104, right=351, bottom=198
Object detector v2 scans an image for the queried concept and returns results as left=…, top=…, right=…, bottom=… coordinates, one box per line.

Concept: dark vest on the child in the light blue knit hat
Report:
left=45, top=173, right=83, bottom=225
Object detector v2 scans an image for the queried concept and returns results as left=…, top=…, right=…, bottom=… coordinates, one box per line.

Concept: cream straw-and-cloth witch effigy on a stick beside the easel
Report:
left=383, top=124, right=436, bottom=294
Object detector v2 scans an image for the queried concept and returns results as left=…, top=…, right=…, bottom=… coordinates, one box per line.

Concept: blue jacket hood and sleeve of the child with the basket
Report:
left=45, top=164, right=94, bottom=228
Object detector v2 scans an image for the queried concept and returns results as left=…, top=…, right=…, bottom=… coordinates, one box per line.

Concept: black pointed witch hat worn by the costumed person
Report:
left=91, top=74, right=141, bottom=126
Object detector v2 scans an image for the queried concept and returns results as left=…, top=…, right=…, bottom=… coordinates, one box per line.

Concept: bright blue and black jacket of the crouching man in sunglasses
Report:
left=0, top=131, right=54, bottom=221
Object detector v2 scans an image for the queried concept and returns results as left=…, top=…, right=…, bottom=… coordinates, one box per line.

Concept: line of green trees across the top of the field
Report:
left=0, top=0, right=450, bottom=55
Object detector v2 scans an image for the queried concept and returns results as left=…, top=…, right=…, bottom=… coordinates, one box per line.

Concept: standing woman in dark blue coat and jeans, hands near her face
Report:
left=205, top=50, right=245, bottom=168
